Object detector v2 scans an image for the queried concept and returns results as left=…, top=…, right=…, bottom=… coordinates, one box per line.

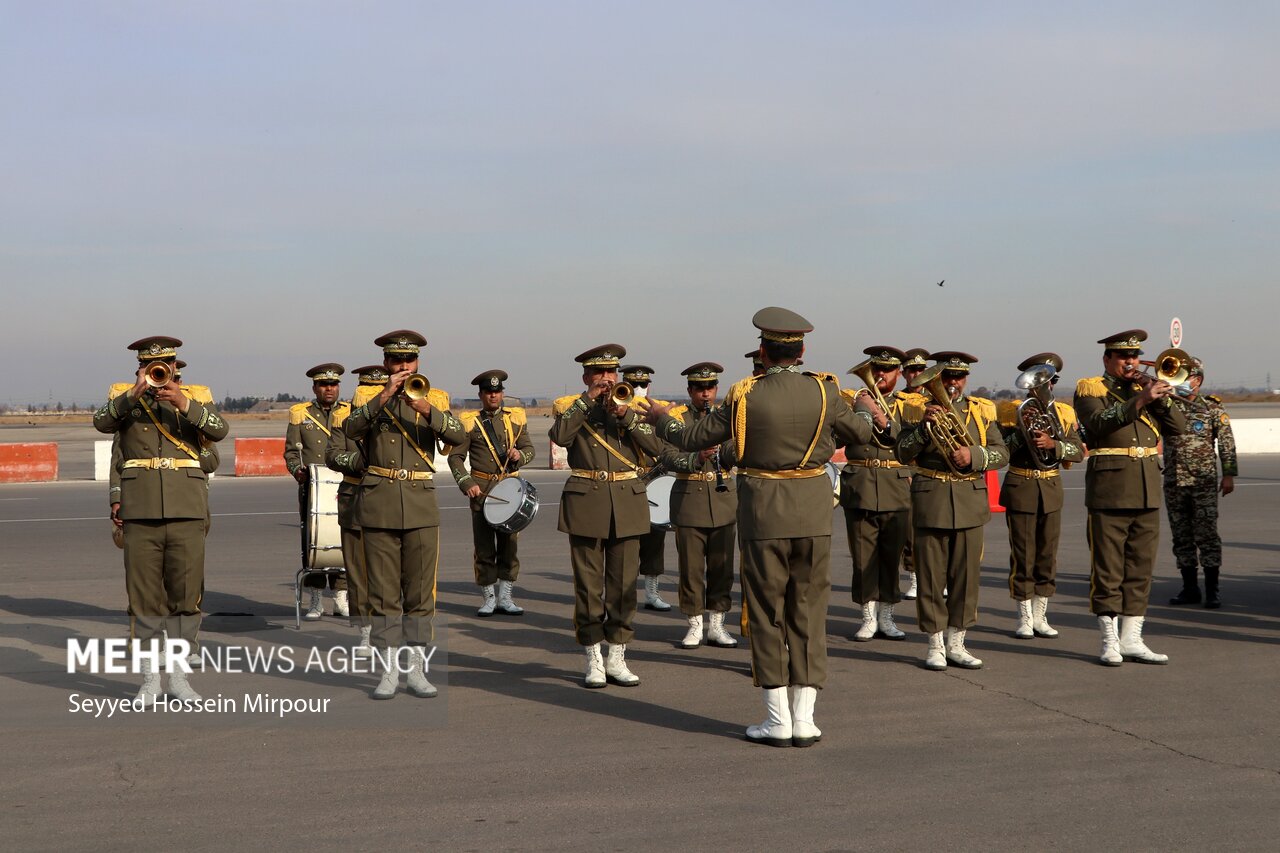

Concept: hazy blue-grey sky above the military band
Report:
left=0, top=0, right=1280, bottom=402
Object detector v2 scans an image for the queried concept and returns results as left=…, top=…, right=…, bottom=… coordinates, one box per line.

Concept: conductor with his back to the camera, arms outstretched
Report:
left=649, top=307, right=872, bottom=747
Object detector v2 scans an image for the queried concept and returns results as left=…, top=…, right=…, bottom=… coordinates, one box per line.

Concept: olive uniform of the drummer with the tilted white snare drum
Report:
left=449, top=384, right=534, bottom=587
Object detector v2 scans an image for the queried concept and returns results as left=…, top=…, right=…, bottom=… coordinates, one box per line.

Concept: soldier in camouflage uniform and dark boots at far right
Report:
left=1165, top=359, right=1239, bottom=610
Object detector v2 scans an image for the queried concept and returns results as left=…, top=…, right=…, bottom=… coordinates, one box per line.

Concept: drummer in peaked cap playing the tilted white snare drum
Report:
left=449, top=370, right=534, bottom=616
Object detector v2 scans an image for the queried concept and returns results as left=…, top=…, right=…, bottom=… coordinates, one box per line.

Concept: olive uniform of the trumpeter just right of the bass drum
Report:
left=346, top=336, right=465, bottom=649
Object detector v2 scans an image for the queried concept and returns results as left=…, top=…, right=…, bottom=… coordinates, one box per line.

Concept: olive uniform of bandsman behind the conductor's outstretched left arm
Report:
left=662, top=406, right=737, bottom=616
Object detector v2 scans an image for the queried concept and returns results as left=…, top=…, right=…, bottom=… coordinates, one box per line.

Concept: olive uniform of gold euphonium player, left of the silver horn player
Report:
left=896, top=353, right=1009, bottom=630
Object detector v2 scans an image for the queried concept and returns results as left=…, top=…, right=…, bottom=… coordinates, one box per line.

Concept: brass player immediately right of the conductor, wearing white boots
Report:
left=840, top=346, right=911, bottom=642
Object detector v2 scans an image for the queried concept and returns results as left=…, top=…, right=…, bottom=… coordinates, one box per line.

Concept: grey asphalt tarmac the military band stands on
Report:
left=0, top=455, right=1280, bottom=850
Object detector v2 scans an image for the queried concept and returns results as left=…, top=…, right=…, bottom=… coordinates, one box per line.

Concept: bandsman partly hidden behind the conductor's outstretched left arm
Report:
left=662, top=361, right=737, bottom=648
